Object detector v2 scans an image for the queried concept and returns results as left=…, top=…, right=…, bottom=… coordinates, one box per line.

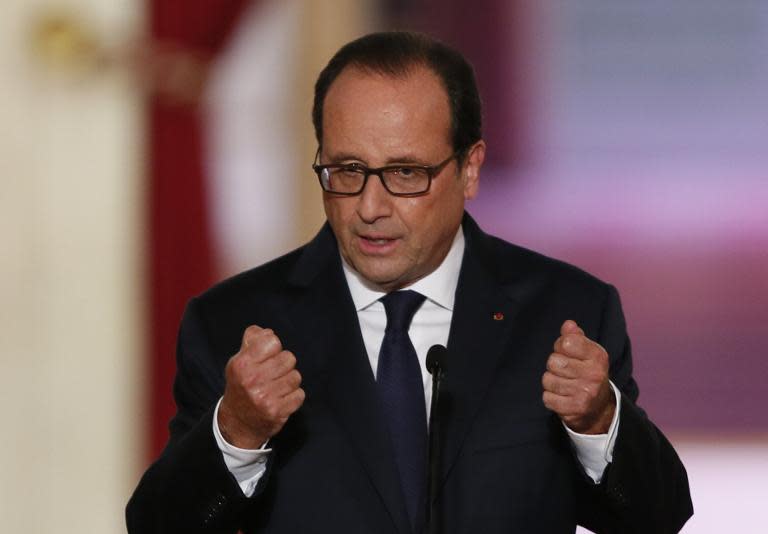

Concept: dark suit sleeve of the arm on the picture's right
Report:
left=578, top=286, right=693, bottom=534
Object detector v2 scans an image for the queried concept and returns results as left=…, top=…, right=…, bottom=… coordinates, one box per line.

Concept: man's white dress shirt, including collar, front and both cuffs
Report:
left=213, top=228, right=621, bottom=497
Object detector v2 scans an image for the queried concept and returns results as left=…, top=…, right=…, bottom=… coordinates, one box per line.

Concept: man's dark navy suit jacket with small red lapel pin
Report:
left=127, top=215, right=692, bottom=534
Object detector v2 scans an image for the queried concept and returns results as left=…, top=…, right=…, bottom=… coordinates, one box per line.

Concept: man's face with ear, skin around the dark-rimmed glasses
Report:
left=320, top=67, right=485, bottom=291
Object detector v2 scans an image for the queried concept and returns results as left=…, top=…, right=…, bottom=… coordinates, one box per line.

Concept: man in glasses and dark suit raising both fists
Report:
left=127, top=33, right=692, bottom=534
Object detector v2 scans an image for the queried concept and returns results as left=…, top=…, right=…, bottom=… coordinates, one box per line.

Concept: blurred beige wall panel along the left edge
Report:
left=0, top=0, right=144, bottom=533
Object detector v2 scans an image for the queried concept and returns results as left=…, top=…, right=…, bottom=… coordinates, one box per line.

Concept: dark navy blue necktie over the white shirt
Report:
left=376, top=290, right=427, bottom=532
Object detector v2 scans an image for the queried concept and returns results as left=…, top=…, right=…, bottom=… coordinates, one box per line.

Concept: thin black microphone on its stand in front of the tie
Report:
left=427, top=345, right=448, bottom=534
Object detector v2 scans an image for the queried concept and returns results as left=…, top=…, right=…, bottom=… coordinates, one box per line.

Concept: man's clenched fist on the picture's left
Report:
left=218, top=326, right=304, bottom=449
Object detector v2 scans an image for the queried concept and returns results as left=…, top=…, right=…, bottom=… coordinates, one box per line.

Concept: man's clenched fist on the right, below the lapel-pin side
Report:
left=541, top=320, right=616, bottom=434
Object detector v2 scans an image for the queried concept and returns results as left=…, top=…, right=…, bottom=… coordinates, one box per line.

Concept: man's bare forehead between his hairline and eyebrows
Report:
left=323, top=65, right=451, bottom=157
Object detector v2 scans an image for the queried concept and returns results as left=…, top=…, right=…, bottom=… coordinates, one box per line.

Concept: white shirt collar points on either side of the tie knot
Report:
left=341, top=226, right=464, bottom=311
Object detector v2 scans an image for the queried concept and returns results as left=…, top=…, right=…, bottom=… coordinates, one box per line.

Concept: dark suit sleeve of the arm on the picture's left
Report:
left=126, top=300, right=260, bottom=533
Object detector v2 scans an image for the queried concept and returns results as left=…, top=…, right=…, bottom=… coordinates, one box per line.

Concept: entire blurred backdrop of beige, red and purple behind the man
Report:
left=0, top=0, right=768, bottom=533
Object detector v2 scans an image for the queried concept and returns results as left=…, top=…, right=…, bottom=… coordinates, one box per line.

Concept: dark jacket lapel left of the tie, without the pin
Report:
left=282, top=225, right=410, bottom=533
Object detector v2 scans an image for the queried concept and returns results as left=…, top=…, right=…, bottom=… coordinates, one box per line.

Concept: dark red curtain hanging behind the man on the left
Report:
left=146, top=0, right=252, bottom=458
